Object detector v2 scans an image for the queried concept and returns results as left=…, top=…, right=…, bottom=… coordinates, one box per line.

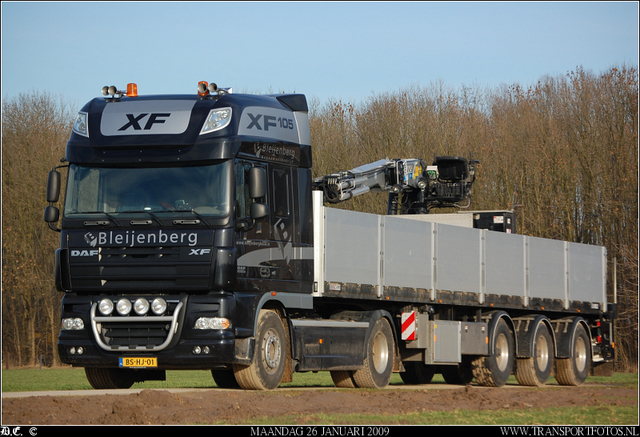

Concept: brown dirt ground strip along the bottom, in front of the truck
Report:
left=2, top=383, right=638, bottom=426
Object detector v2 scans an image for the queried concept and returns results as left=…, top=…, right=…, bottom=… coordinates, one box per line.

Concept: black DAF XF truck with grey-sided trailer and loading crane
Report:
left=44, top=81, right=616, bottom=390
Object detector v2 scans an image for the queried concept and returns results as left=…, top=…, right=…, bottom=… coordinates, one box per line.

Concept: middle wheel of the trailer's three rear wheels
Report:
left=516, top=322, right=553, bottom=387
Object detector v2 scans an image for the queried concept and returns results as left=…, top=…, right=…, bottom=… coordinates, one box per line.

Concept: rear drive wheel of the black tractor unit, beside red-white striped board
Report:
left=353, top=318, right=394, bottom=388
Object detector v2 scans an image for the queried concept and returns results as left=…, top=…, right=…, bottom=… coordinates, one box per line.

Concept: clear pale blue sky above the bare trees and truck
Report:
left=2, top=1, right=638, bottom=109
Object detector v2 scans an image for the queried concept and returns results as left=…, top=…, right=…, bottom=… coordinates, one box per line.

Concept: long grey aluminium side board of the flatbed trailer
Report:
left=313, top=192, right=607, bottom=312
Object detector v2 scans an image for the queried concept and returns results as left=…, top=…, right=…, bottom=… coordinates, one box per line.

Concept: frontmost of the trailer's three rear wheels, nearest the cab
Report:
left=472, top=319, right=515, bottom=387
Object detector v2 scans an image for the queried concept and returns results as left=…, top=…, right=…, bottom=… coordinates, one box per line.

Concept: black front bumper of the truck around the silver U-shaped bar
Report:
left=58, top=295, right=253, bottom=369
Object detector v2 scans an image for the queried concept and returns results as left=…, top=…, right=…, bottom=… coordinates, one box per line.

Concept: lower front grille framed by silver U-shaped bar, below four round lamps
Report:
left=91, top=302, right=183, bottom=351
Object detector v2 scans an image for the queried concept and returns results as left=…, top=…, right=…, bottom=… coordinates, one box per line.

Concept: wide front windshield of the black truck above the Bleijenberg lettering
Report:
left=65, top=161, right=231, bottom=217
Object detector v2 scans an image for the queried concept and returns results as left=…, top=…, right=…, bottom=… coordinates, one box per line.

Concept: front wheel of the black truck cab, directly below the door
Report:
left=233, top=310, right=287, bottom=390
